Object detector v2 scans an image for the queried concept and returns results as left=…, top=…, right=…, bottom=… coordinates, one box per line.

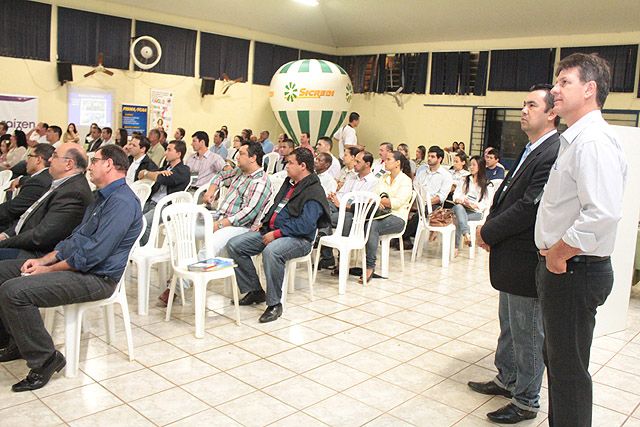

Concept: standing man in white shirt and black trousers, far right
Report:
left=535, top=53, right=627, bottom=427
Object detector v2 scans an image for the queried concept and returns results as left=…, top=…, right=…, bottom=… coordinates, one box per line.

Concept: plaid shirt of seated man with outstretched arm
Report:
left=211, top=168, right=271, bottom=227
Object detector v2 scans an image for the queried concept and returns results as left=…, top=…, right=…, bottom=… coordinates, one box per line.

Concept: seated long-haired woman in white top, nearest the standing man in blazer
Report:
left=453, top=156, right=491, bottom=255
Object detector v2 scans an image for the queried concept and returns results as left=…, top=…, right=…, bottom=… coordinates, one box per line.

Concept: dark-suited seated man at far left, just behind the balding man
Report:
left=0, top=144, right=55, bottom=230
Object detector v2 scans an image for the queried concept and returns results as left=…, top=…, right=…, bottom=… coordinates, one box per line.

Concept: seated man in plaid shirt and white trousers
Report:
left=203, top=142, right=270, bottom=256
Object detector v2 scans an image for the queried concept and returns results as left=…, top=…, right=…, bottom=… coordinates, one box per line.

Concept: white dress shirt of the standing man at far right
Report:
left=535, top=110, right=627, bottom=256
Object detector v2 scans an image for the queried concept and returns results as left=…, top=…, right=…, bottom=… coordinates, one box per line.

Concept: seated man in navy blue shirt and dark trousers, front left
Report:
left=0, top=144, right=142, bottom=392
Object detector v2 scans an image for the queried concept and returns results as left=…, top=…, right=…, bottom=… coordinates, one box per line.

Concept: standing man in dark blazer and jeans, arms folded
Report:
left=468, top=84, right=560, bottom=424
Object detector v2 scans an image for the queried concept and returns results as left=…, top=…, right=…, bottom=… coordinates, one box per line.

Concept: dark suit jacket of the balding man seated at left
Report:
left=0, top=173, right=93, bottom=254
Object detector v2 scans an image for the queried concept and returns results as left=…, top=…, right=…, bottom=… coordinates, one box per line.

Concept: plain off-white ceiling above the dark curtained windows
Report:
left=103, top=0, right=640, bottom=48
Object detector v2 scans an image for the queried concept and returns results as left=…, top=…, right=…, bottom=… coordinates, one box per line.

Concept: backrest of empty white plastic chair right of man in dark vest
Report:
left=336, top=191, right=380, bottom=242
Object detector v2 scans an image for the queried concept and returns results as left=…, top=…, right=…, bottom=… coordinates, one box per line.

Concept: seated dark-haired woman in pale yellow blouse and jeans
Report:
left=360, top=151, right=413, bottom=282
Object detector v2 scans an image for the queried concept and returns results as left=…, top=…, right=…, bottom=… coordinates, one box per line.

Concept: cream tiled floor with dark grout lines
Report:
left=0, top=246, right=640, bottom=427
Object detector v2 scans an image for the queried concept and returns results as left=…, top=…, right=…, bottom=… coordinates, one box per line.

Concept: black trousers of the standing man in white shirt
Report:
left=536, top=259, right=613, bottom=427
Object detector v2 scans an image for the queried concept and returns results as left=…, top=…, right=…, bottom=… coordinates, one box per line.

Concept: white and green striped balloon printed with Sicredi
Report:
left=269, top=59, right=353, bottom=149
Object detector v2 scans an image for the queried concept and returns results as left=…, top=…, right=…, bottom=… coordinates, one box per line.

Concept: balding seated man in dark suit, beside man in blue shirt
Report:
left=0, top=144, right=93, bottom=259
